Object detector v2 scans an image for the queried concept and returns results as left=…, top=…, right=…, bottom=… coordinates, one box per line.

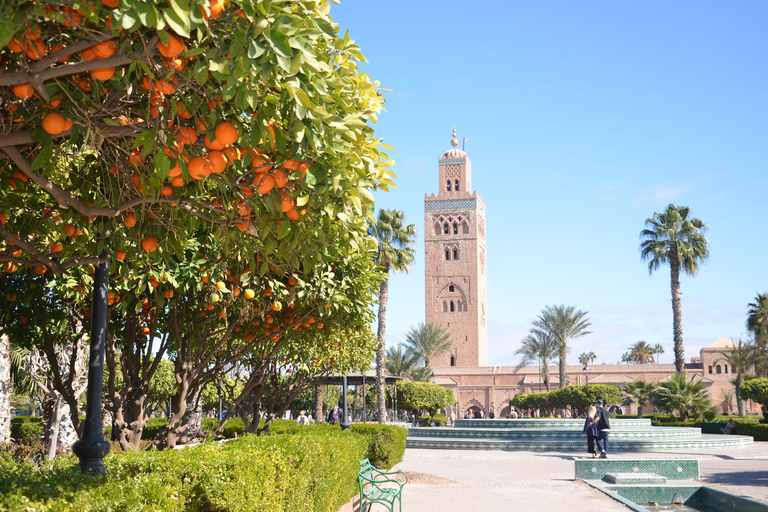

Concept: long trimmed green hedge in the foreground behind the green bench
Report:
left=0, top=430, right=372, bottom=512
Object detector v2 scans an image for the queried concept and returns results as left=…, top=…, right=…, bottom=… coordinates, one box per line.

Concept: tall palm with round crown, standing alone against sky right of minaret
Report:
left=640, top=204, right=709, bottom=372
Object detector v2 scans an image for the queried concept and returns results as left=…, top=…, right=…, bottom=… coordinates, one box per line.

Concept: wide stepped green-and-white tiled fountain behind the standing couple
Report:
left=408, top=418, right=753, bottom=452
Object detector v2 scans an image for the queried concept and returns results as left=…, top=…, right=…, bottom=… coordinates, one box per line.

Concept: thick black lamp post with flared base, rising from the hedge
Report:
left=72, top=251, right=110, bottom=475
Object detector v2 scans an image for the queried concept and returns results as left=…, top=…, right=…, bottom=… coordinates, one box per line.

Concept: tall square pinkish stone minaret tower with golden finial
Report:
left=424, top=127, right=488, bottom=368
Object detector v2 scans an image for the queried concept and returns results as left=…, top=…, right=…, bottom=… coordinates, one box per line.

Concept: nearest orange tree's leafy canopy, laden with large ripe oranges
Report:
left=0, top=0, right=393, bottom=273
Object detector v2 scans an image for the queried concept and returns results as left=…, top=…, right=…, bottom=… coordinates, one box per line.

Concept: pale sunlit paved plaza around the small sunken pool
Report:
left=397, top=442, right=768, bottom=512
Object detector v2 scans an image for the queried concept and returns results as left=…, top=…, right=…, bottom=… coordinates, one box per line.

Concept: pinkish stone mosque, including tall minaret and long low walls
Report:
left=423, top=129, right=760, bottom=417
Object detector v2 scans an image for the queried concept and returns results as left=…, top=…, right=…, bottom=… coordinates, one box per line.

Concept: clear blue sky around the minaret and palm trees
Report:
left=331, top=0, right=768, bottom=365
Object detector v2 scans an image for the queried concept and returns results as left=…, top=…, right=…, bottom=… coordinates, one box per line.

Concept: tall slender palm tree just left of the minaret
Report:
left=368, top=210, right=418, bottom=422
